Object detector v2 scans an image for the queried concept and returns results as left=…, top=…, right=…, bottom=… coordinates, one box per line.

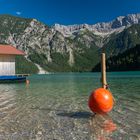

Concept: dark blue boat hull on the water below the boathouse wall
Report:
left=0, top=75, right=26, bottom=83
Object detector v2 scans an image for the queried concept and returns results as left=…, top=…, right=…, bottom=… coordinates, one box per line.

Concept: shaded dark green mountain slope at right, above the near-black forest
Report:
left=102, top=24, right=140, bottom=57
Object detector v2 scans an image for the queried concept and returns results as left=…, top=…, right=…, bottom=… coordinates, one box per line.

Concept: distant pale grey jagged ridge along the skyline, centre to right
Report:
left=54, top=14, right=140, bottom=36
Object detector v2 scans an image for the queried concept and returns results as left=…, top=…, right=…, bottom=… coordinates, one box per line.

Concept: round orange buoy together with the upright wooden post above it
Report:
left=88, top=53, right=114, bottom=114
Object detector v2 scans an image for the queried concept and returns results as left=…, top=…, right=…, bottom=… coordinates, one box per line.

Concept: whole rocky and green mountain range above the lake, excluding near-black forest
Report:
left=0, top=14, right=140, bottom=71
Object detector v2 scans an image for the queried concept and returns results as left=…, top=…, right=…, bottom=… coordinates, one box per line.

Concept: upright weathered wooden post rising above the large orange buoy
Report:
left=101, top=53, right=107, bottom=89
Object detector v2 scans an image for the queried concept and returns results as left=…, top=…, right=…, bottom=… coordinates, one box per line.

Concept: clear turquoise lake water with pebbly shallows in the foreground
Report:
left=0, top=72, right=140, bottom=140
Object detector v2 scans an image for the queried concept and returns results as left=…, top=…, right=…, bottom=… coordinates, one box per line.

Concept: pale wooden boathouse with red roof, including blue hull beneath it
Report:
left=0, top=45, right=28, bottom=83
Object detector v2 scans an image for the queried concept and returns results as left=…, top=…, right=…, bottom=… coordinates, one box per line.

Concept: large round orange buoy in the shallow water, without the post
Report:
left=88, top=88, right=114, bottom=114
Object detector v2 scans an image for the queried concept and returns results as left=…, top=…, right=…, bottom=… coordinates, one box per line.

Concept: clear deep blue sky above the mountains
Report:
left=0, top=0, right=140, bottom=25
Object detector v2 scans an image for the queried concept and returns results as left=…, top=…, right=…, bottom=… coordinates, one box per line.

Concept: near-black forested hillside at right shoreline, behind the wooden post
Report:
left=92, top=45, right=140, bottom=71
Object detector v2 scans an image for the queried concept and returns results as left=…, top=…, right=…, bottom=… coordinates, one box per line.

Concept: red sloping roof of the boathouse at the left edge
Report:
left=0, top=45, right=25, bottom=55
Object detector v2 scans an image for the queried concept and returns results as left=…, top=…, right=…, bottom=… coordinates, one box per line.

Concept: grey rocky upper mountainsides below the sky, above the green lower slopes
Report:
left=0, top=14, right=140, bottom=71
